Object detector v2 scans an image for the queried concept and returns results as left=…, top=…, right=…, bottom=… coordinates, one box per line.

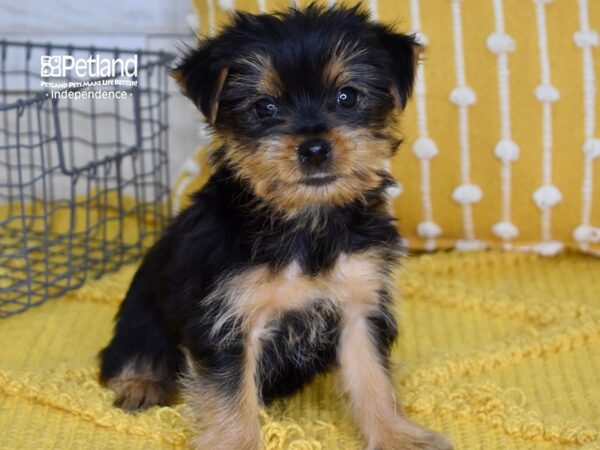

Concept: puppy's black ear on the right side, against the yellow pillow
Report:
left=378, top=27, right=423, bottom=109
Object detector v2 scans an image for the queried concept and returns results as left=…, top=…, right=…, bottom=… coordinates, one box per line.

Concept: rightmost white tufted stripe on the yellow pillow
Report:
left=573, top=0, right=600, bottom=250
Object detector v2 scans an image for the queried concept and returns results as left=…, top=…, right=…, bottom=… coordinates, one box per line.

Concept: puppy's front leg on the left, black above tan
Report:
left=182, top=324, right=261, bottom=450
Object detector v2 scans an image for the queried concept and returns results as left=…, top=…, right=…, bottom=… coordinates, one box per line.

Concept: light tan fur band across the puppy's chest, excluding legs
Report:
left=210, top=250, right=389, bottom=339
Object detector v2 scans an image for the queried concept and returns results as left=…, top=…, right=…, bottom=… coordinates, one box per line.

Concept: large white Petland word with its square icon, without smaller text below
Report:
left=41, top=55, right=137, bottom=78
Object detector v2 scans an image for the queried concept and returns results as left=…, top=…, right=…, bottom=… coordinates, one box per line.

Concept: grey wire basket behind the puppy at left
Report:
left=0, top=41, right=173, bottom=317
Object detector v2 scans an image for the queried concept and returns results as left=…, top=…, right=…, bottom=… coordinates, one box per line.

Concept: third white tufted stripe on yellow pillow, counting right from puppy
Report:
left=486, top=0, right=520, bottom=250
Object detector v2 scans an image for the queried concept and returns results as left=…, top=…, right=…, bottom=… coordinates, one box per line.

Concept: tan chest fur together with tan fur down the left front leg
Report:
left=185, top=250, right=388, bottom=450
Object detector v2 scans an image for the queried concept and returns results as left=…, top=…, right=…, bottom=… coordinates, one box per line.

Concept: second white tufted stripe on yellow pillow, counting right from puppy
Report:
left=450, top=0, right=485, bottom=250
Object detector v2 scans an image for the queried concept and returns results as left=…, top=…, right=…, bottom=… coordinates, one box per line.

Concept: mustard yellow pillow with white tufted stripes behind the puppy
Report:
left=175, top=0, right=600, bottom=255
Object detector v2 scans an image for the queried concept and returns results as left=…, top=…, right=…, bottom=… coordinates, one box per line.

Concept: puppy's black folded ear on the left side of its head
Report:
left=171, top=39, right=228, bottom=125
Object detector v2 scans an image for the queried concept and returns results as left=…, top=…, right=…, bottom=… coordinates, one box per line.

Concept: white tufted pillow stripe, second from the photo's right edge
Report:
left=533, top=0, right=563, bottom=256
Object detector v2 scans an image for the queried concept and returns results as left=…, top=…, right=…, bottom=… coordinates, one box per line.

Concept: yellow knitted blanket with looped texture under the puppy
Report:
left=0, top=252, right=600, bottom=450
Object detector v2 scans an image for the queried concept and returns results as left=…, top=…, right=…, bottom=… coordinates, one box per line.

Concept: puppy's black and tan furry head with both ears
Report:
left=176, top=6, right=419, bottom=215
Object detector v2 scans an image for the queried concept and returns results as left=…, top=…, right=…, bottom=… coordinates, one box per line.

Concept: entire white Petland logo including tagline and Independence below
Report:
left=40, top=55, right=138, bottom=100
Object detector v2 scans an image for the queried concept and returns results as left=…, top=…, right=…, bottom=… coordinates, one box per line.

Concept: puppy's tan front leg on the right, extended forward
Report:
left=338, top=304, right=452, bottom=450
